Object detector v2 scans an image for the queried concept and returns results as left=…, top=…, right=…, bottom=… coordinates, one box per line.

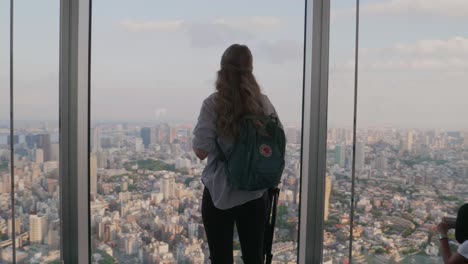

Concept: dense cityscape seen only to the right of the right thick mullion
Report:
left=324, top=128, right=468, bottom=264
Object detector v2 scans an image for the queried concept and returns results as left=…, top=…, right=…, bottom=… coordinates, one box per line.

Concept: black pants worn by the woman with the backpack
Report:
left=202, top=188, right=268, bottom=264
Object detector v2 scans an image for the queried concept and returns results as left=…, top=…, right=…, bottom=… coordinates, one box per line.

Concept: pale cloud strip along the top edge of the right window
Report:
left=332, top=0, right=468, bottom=19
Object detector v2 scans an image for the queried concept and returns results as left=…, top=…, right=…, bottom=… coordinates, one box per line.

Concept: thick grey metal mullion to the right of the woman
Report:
left=299, top=0, right=330, bottom=264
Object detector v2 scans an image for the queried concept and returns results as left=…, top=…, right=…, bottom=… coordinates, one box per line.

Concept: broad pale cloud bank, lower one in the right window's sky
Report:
left=331, top=37, right=468, bottom=73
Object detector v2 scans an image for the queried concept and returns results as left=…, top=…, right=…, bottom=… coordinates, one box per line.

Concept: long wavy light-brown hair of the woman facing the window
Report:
left=215, top=44, right=263, bottom=138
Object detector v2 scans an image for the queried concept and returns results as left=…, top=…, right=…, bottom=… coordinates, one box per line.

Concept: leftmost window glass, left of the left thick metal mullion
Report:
left=7, top=1, right=60, bottom=263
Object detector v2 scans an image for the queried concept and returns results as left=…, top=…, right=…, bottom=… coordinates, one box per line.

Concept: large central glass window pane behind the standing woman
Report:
left=90, top=1, right=304, bottom=263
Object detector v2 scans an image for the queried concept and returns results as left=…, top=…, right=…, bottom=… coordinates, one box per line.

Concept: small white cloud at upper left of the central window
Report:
left=120, top=19, right=184, bottom=32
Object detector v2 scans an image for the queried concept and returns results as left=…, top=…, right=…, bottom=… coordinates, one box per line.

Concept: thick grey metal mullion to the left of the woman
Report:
left=59, top=0, right=91, bottom=264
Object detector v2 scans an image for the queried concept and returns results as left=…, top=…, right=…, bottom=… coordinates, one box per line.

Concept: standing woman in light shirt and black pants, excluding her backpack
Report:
left=193, top=44, right=276, bottom=264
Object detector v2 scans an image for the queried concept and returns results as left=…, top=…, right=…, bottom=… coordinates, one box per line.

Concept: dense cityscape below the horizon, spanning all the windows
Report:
left=0, top=123, right=468, bottom=264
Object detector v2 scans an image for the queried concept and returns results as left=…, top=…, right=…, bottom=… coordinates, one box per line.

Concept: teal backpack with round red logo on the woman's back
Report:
left=215, top=115, right=286, bottom=191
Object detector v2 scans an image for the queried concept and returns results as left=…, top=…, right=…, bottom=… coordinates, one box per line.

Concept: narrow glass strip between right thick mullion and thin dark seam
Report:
left=323, top=0, right=356, bottom=264
